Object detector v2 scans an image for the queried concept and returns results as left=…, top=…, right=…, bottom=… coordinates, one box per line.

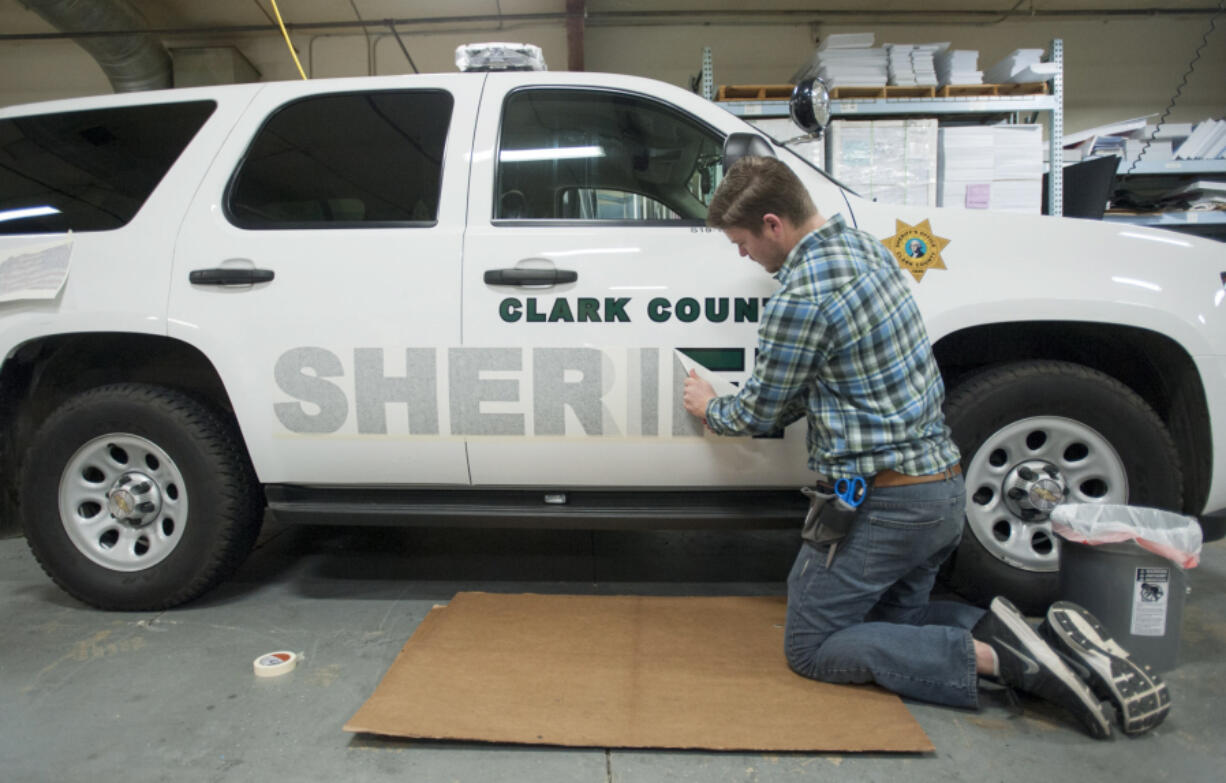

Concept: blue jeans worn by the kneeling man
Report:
left=785, top=475, right=983, bottom=707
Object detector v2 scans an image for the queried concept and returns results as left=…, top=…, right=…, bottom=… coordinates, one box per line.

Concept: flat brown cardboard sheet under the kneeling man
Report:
left=345, top=593, right=933, bottom=751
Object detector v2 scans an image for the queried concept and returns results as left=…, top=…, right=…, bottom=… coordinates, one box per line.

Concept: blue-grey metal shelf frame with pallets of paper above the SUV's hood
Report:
left=702, top=38, right=1064, bottom=214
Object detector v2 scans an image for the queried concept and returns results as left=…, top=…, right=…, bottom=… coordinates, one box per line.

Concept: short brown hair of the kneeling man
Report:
left=706, top=156, right=818, bottom=236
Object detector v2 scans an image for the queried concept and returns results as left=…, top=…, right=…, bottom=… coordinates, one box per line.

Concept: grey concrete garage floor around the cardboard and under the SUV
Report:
left=7, top=520, right=1226, bottom=783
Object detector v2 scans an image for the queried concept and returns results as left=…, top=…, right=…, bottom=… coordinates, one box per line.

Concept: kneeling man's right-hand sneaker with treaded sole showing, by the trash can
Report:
left=1038, top=600, right=1171, bottom=734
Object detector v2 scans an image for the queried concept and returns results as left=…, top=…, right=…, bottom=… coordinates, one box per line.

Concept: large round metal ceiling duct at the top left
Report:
left=21, top=0, right=173, bottom=92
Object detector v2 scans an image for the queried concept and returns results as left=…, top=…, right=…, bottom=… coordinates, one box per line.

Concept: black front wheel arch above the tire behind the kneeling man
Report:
left=933, top=321, right=1213, bottom=515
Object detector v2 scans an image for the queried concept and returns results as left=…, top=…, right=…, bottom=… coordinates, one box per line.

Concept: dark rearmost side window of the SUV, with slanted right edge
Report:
left=0, top=100, right=217, bottom=234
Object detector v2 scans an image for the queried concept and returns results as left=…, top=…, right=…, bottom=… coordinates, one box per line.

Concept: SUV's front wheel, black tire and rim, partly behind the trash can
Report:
left=943, top=360, right=1183, bottom=614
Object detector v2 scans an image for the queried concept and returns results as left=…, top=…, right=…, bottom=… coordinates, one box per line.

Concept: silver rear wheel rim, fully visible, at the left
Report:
left=59, top=433, right=188, bottom=571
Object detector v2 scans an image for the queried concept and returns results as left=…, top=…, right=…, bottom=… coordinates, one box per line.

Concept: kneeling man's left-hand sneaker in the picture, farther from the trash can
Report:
left=971, top=596, right=1111, bottom=739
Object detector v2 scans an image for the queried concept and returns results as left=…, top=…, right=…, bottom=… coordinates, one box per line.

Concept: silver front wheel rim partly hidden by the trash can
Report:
left=965, top=417, right=1128, bottom=571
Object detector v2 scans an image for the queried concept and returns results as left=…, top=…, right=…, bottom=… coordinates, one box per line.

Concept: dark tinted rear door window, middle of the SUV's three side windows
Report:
left=228, top=91, right=452, bottom=229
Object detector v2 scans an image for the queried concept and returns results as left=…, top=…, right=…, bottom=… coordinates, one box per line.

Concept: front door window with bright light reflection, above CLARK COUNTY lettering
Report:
left=494, top=89, right=722, bottom=222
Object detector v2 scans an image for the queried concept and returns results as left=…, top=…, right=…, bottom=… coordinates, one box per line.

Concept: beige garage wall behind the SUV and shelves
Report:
left=0, top=17, right=1226, bottom=137
